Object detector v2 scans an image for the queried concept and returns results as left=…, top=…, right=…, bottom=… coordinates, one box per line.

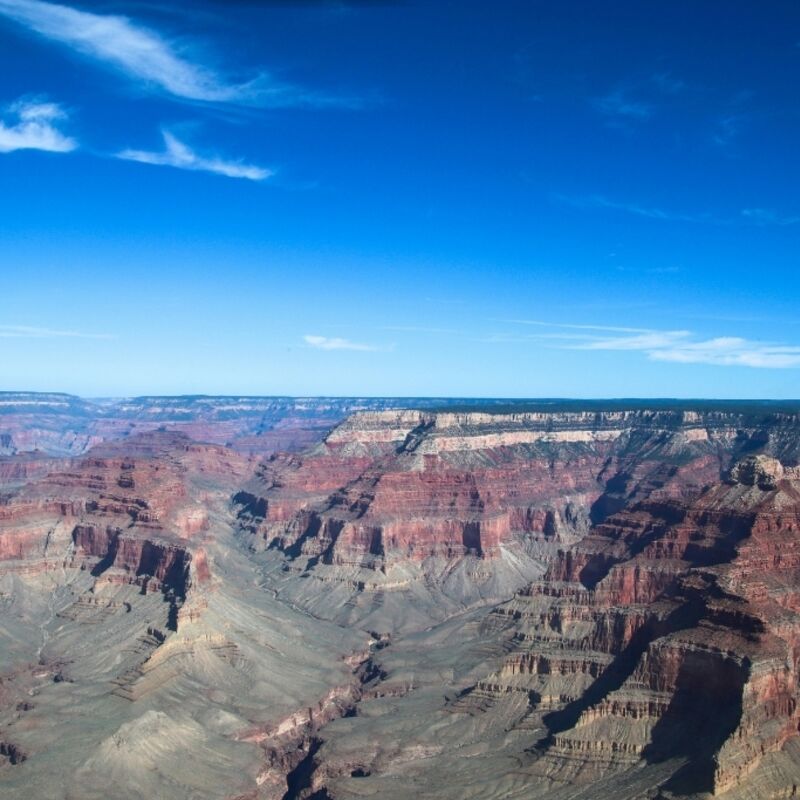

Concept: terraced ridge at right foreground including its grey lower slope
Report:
left=312, top=457, right=800, bottom=798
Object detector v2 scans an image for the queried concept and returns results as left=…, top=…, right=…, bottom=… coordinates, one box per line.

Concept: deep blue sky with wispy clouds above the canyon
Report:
left=0, top=0, right=800, bottom=398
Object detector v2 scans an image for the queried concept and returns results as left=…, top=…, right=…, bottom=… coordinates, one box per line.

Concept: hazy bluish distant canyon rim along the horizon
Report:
left=7, top=392, right=796, bottom=459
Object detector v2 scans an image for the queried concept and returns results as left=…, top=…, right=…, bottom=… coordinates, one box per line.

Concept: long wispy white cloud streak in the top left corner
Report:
left=0, top=0, right=338, bottom=107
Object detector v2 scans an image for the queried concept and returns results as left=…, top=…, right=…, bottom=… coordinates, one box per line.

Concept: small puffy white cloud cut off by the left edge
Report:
left=0, top=98, right=78, bottom=153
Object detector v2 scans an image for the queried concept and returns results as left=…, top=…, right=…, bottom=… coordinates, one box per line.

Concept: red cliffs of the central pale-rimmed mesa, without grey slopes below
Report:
left=236, top=412, right=772, bottom=569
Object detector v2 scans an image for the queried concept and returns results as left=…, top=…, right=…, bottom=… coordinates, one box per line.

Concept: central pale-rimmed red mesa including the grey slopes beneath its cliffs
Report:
left=235, top=411, right=796, bottom=629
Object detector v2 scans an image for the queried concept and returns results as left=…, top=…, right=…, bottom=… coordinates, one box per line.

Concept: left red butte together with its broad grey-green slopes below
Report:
left=0, top=432, right=370, bottom=800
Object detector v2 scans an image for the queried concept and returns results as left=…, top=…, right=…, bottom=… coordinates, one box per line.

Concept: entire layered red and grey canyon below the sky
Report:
left=0, top=395, right=800, bottom=800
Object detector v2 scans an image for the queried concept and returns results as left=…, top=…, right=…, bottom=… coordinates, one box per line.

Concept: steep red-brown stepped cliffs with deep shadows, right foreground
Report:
left=473, top=458, right=800, bottom=794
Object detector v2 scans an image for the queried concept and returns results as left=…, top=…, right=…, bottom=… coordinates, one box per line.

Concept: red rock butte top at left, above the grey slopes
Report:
left=0, top=432, right=251, bottom=598
